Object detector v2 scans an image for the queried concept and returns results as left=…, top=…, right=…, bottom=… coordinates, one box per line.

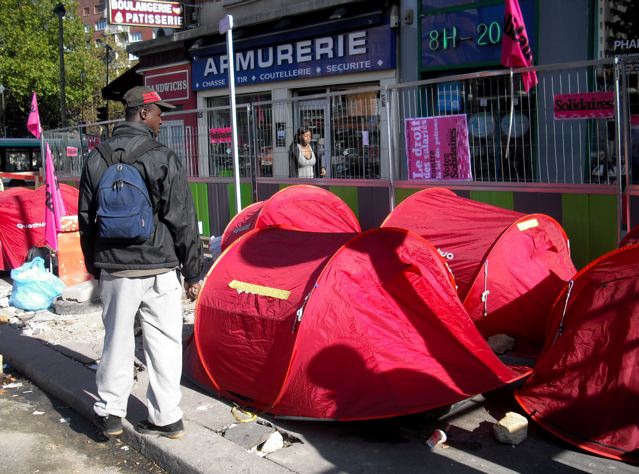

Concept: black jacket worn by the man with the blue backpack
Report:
left=78, top=122, right=202, bottom=283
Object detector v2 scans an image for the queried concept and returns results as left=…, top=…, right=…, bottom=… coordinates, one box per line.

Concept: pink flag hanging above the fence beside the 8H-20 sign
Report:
left=501, top=0, right=539, bottom=92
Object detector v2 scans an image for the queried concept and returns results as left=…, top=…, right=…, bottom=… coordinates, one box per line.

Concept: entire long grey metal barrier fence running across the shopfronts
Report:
left=44, top=60, right=639, bottom=191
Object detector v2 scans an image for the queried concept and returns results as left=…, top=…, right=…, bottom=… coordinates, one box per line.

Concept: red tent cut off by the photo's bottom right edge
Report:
left=516, top=245, right=639, bottom=463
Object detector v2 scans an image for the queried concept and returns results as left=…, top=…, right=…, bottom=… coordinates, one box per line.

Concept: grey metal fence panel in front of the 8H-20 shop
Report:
left=389, top=62, right=616, bottom=184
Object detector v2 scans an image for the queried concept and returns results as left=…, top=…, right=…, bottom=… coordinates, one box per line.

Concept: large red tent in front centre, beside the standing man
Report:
left=186, top=227, right=522, bottom=420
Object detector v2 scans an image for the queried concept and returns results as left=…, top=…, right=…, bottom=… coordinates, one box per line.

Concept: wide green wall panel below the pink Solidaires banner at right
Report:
left=562, top=194, right=617, bottom=268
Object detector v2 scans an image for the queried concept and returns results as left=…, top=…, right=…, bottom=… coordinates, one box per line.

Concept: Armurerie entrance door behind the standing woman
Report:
left=294, top=99, right=331, bottom=177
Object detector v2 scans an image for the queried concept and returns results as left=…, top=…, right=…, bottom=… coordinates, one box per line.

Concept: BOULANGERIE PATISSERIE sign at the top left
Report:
left=108, top=0, right=184, bottom=28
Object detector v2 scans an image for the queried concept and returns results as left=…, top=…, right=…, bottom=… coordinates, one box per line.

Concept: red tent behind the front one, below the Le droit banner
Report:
left=382, top=188, right=576, bottom=355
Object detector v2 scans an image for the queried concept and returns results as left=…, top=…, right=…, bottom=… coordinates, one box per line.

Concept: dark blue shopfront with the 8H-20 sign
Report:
left=419, top=0, right=538, bottom=181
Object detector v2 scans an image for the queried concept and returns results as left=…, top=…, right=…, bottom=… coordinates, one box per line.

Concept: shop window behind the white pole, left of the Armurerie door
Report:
left=206, top=93, right=273, bottom=177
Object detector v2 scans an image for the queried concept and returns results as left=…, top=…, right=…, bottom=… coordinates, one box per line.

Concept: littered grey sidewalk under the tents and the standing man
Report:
left=0, top=280, right=639, bottom=474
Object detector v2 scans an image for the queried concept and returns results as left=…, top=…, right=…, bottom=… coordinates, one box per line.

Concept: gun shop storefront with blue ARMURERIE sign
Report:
left=191, top=13, right=396, bottom=178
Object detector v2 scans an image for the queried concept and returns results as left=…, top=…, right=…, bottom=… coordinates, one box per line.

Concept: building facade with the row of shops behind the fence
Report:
left=57, top=0, right=639, bottom=264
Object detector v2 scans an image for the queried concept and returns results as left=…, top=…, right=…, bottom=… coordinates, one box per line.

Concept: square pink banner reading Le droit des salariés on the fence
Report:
left=404, top=114, right=473, bottom=180
